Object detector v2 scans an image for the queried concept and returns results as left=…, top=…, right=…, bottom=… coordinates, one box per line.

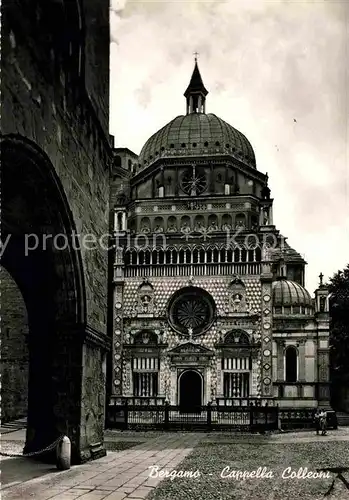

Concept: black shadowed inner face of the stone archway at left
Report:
left=1, top=136, right=105, bottom=463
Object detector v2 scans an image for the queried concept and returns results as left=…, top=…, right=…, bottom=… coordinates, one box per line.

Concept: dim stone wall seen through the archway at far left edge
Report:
left=0, top=267, right=29, bottom=422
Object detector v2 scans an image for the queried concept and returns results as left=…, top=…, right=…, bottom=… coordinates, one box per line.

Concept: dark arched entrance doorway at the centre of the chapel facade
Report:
left=179, top=370, right=203, bottom=413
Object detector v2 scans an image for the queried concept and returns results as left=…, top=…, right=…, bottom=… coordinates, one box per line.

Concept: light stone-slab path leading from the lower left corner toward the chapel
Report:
left=1, top=433, right=202, bottom=500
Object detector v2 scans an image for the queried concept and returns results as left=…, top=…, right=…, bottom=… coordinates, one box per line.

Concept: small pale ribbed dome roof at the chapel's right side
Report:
left=273, top=278, right=312, bottom=307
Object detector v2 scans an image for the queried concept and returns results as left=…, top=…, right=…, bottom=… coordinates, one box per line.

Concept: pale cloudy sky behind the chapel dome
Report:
left=110, top=0, right=349, bottom=293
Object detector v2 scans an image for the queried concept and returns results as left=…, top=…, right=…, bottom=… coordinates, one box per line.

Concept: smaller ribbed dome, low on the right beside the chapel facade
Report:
left=272, top=278, right=313, bottom=314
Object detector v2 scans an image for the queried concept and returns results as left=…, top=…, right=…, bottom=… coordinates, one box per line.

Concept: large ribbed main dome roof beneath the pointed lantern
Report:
left=138, top=113, right=256, bottom=171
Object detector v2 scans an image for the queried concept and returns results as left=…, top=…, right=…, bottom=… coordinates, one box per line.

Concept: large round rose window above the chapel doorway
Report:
left=168, top=287, right=215, bottom=335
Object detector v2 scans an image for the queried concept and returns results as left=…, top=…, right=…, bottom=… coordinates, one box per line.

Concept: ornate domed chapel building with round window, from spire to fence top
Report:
left=110, top=61, right=329, bottom=412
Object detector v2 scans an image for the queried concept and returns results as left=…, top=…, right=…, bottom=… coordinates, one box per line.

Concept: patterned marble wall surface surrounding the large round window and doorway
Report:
left=119, top=276, right=264, bottom=401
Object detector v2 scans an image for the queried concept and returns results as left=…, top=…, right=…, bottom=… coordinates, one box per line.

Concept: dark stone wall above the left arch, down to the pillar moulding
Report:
left=1, top=0, right=111, bottom=333
